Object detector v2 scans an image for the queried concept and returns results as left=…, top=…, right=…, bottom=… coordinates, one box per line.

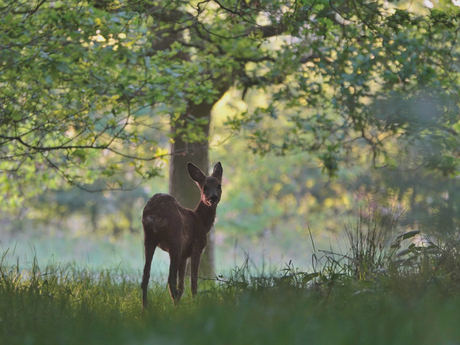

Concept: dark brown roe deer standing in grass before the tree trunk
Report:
left=141, top=162, right=223, bottom=308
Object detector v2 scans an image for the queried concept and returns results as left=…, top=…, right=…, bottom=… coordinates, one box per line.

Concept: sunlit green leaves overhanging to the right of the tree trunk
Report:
left=217, top=1, right=460, bottom=173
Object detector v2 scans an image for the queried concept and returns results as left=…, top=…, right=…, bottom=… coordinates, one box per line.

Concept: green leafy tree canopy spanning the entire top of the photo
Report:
left=0, top=0, right=459, bottom=207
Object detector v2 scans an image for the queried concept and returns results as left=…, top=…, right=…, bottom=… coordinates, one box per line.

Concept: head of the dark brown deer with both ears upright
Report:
left=187, top=162, right=223, bottom=206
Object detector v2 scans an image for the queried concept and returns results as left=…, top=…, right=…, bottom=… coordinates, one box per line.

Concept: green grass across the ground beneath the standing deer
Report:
left=0, top=236, right=460, bottom=345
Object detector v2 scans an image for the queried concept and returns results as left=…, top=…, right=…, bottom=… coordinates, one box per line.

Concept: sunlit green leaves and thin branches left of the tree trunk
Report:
left=0, top=1, right=212, bottom=206
